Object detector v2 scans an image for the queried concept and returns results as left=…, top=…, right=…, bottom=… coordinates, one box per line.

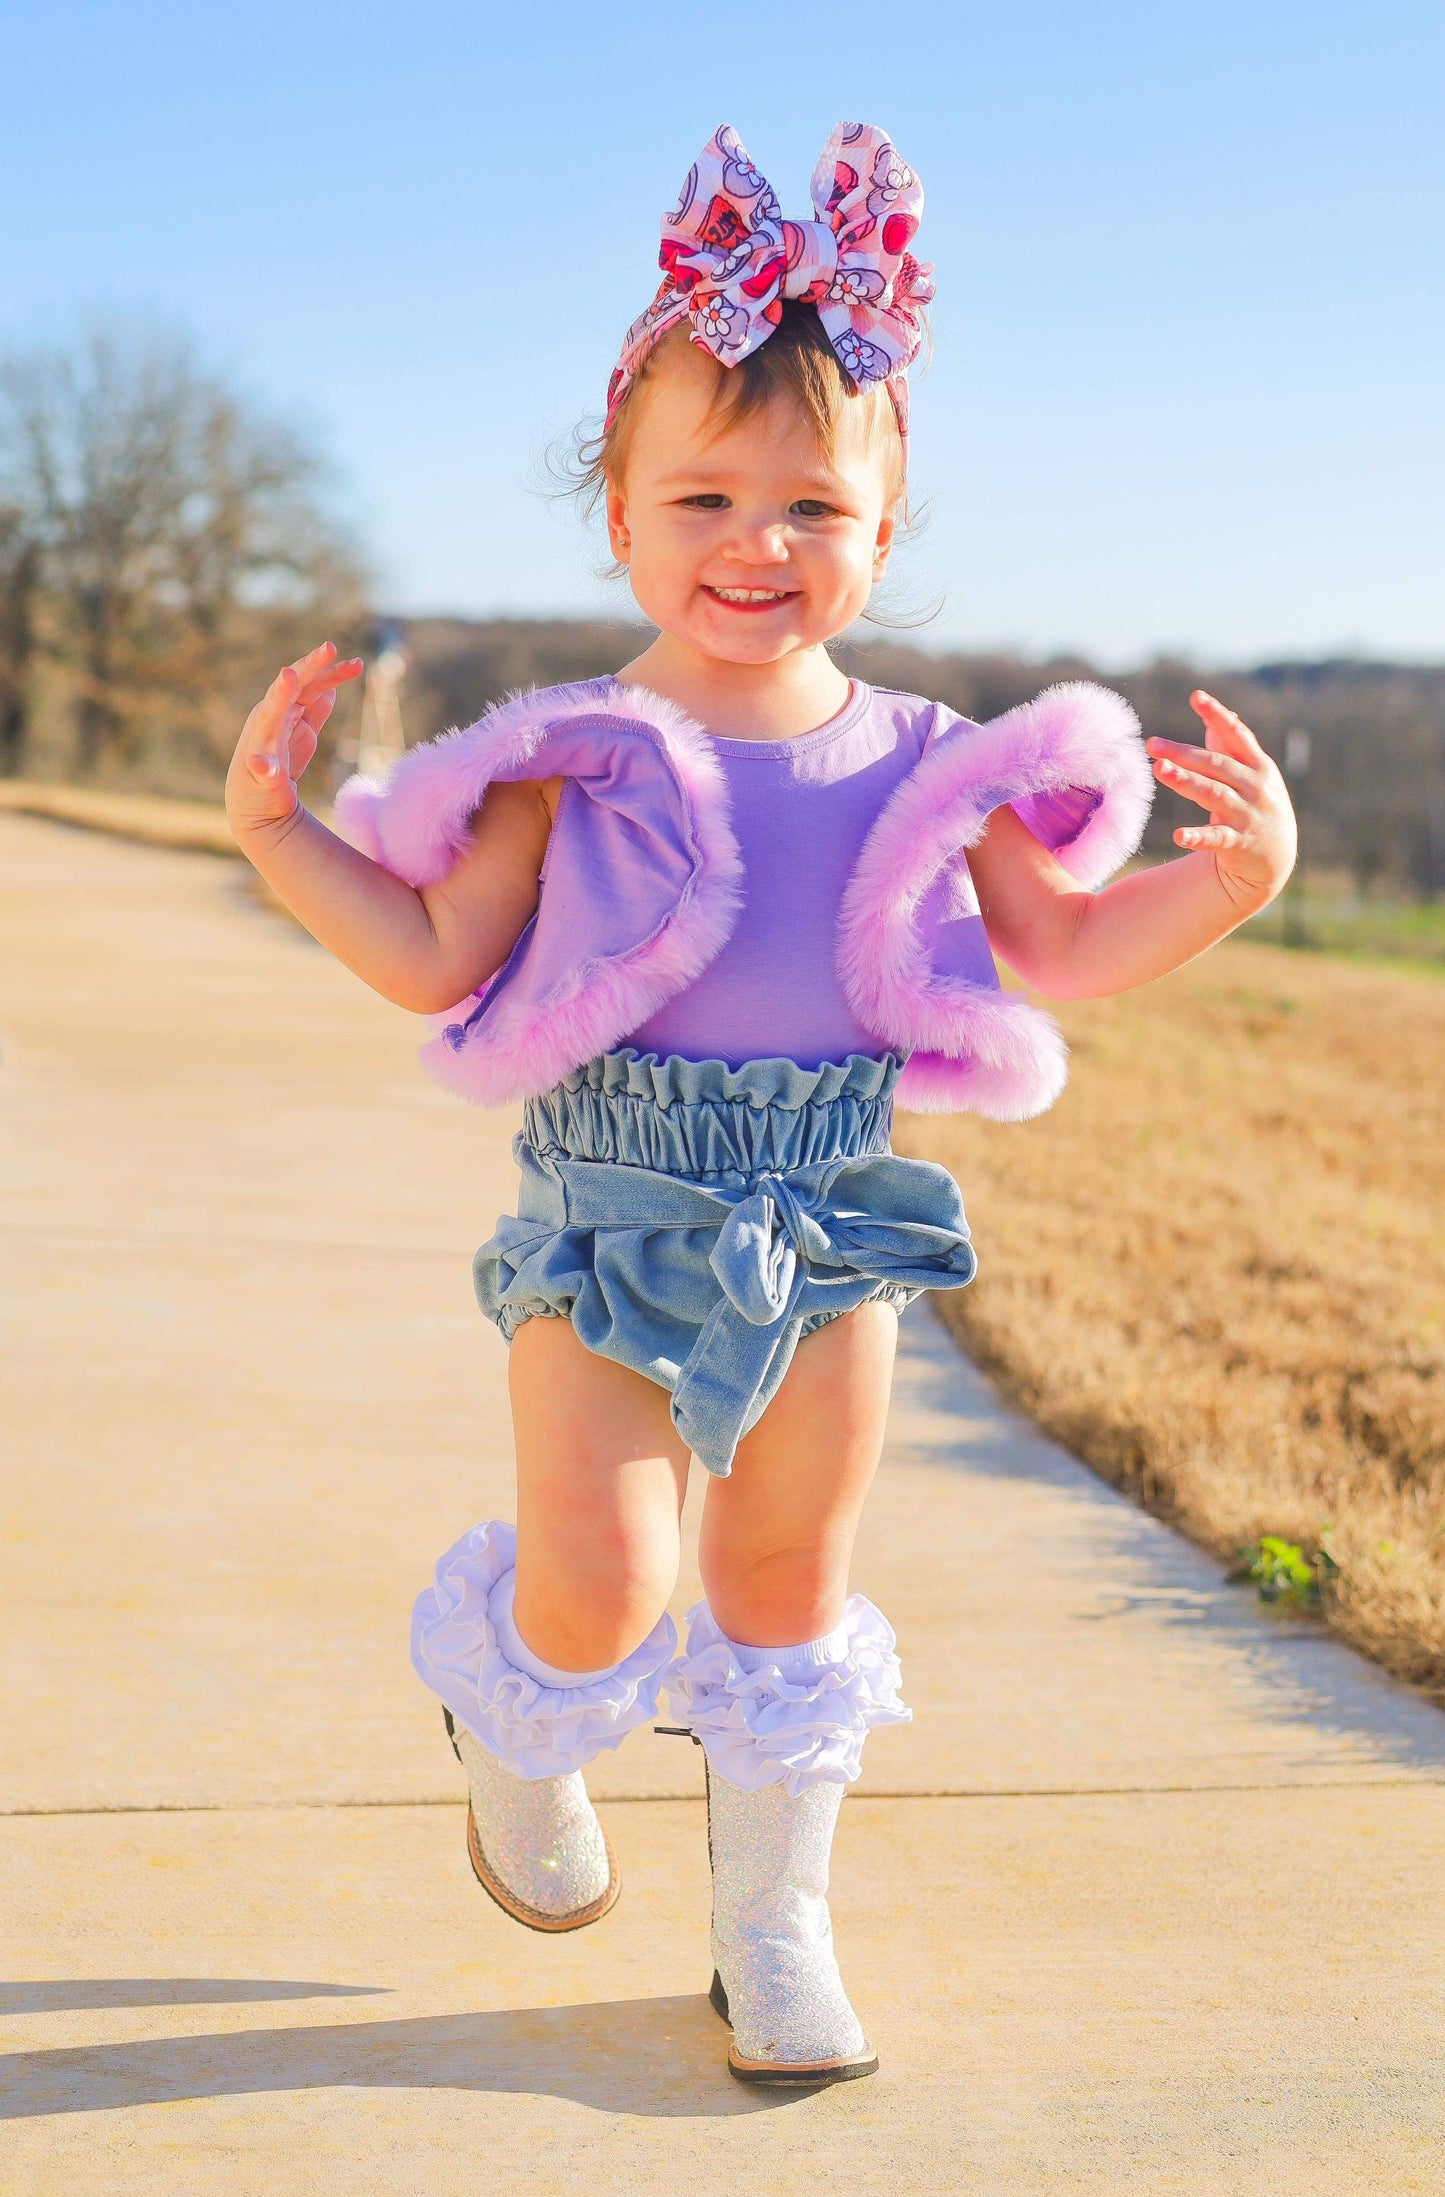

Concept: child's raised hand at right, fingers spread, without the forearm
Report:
left=1144, top=688, right=1296, bottom=907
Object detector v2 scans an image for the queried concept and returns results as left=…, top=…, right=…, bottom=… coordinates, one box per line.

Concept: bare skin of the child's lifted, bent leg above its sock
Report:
left=509, top=1318, right=687, bottom=1670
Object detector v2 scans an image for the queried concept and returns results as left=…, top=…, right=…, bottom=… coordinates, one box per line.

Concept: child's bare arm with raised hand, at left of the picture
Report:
left=226, top=642, right=551, bottom=1015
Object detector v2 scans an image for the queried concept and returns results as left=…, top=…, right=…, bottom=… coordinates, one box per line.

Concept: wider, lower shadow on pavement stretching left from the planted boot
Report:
left=0, top=1993, right=794, bottom=2120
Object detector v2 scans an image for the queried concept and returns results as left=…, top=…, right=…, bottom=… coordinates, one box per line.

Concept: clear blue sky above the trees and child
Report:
left=0, top=0, right=1445, bottom=663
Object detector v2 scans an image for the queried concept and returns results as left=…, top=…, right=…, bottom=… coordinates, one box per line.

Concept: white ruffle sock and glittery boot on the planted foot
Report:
left=668, top=1595, right=911, bottom=2085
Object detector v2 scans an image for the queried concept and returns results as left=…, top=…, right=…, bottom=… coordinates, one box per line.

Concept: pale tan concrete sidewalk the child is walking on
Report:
left=0, top=815, right=1445, bottom=2197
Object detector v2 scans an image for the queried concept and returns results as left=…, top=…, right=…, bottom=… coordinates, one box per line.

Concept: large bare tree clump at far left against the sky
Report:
left=0, top=323, right=360, bottom=776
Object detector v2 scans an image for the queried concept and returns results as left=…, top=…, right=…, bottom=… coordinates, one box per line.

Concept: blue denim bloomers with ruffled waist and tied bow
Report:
left=472, top=1048, right=977, bottom=1474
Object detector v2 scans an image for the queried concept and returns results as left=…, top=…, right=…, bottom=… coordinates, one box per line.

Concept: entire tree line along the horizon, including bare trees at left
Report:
left=0, top=321, right=1445, bottom=896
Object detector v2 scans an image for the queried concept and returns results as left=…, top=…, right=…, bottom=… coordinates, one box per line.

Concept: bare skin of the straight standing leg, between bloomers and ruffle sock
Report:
left=698, top=1303, right=898, bottom=1648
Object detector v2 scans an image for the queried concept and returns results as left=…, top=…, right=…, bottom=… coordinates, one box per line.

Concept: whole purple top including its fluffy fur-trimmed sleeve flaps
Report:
left=336, top=679, right=1153, bottom=1120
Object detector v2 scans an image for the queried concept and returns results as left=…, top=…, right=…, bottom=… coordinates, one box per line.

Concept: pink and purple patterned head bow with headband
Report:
left=606, top=123, right=933, bottom=452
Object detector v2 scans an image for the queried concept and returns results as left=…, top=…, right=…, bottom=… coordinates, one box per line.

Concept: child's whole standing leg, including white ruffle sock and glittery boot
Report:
left=674, top=1303, right=907, bottom=2083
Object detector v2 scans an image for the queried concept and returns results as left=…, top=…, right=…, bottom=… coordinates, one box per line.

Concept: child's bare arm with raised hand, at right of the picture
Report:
left=968, top=692, right=1296, bottom=1000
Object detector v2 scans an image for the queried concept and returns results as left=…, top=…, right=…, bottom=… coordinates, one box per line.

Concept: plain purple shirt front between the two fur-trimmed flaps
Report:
left=621, top=679, right=993, bottom=1068
